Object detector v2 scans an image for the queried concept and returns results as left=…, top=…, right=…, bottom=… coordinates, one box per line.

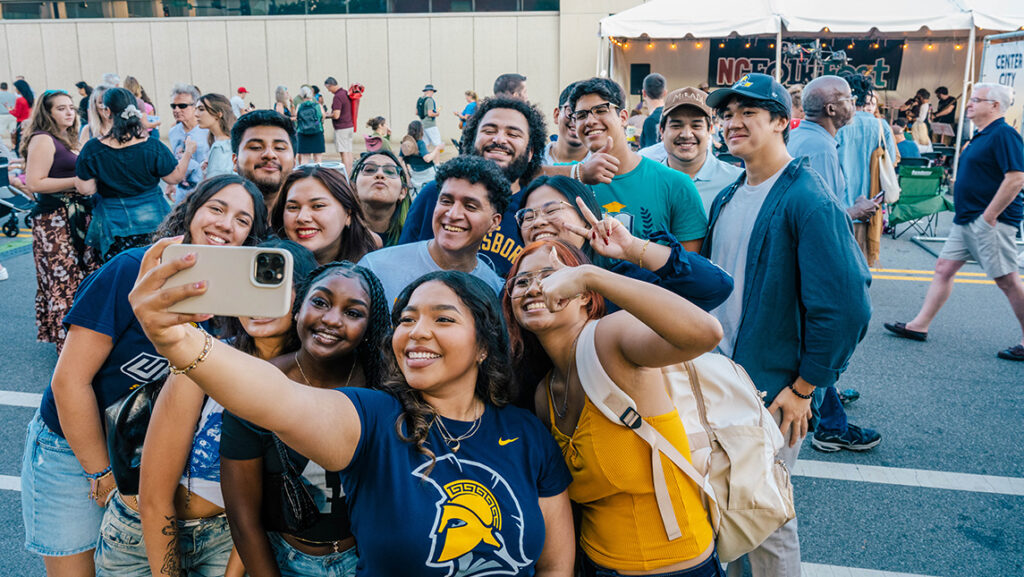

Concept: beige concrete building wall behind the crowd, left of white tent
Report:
left=0, top=11, right=569, bottom=140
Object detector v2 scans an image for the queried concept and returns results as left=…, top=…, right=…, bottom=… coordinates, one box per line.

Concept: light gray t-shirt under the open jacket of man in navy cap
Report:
left=711, top=165, right=788, bottom=358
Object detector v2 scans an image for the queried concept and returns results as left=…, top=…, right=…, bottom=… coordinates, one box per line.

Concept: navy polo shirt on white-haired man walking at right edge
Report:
left=953, top=118, right=1024, bottom=226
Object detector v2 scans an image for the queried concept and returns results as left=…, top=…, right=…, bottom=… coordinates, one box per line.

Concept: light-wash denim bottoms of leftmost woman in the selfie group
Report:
left=22, top=411, right=103, bottom=557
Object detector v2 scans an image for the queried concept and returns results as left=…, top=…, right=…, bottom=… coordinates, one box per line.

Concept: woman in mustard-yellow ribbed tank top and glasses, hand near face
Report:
left=502, top=239, right=725, bottom=577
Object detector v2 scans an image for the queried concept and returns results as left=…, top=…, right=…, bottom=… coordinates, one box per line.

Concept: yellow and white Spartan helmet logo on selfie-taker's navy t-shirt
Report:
left=413, top=453, right=532, bottom=577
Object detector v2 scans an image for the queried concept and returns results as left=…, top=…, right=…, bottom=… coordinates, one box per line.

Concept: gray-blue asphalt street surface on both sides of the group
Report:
left=0, top=214, right=1024, bottom=577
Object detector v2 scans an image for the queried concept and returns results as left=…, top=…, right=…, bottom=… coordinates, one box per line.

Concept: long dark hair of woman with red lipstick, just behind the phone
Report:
left=270, top=165, right=377, bottom=262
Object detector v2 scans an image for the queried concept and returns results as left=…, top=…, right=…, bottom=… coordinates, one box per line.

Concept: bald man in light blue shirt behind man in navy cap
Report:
left=786, top=76, right=882, bottom=453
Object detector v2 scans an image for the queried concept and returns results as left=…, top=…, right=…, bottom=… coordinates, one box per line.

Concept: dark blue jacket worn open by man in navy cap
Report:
left=701, top=159, right=871, bottom=403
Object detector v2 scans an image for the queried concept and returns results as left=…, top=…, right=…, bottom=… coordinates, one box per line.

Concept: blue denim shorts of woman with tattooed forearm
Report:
left=94, top=493, right=231, bottom=577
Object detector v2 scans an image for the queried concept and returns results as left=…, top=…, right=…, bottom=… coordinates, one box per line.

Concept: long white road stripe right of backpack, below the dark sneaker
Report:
left=794, top=460, right=1024, bottom=496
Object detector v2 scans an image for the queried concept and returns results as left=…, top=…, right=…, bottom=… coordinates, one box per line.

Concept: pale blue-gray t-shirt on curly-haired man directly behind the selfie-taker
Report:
left=359, top=240, right=505, bottom=310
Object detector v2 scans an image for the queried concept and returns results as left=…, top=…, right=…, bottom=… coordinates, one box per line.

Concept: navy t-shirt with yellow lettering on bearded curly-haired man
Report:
left=398, top=182, right=522, bottom=279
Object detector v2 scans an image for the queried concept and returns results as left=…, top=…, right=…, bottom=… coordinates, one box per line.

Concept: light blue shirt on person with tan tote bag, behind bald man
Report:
left=835, top=111, right=896, bottom=208
